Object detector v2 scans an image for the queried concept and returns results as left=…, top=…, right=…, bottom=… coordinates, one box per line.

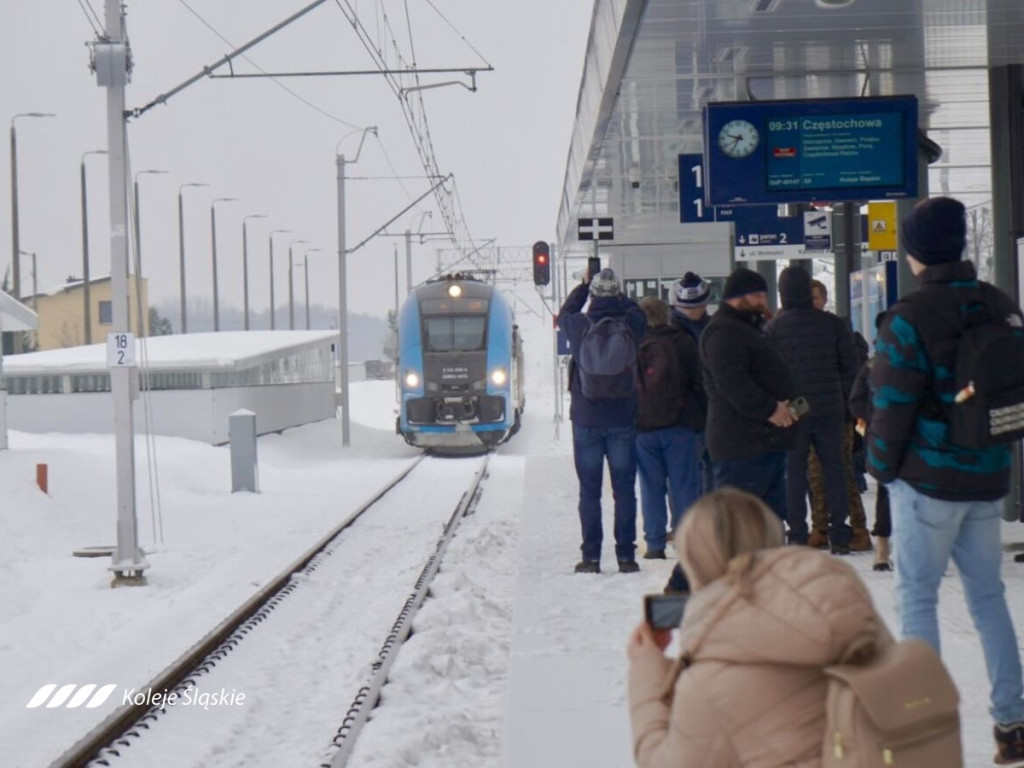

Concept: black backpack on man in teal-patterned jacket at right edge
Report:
left=917, top=284, right=1024, bottom=450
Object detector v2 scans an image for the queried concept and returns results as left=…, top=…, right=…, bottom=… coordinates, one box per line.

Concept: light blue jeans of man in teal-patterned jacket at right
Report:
left=888, top=480, right=1024, bottom=724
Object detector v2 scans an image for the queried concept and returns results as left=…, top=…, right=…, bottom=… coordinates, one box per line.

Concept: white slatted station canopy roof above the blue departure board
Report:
left=558, top=0, right=1024, bottom=247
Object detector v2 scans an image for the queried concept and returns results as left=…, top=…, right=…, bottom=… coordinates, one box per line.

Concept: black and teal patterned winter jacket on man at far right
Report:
left=867, top=261, right=1020, bottom=501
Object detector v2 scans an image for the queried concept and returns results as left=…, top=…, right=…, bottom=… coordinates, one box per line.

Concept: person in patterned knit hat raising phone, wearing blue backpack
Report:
left=557, top=269, right=647, bottom=573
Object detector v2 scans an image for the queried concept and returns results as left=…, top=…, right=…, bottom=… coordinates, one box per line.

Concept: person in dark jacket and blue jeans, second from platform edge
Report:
left=637, top=296, right=706, bottom=560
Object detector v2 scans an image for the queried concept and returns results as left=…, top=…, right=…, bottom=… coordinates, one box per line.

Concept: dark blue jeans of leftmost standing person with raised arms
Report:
left=572, top=422, right=637, bottom=560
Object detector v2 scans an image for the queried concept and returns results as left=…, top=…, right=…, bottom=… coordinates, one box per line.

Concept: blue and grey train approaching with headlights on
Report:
left=395, top=273, right=525, bottom=454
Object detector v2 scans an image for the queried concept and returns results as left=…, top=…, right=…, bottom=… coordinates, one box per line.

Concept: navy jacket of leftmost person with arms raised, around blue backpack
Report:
left=557, top=284, right=647, bottom=427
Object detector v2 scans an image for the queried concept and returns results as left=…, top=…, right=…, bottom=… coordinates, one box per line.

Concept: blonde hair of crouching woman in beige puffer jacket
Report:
left=676, top=486, right=784, bottom=590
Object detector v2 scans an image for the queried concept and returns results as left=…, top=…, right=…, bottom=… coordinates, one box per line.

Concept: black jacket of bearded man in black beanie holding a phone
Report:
left=700, top=304, right=799, bottom=461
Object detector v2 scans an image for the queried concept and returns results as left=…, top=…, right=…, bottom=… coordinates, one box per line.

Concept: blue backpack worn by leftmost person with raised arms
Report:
left=577, top=314, right=637, bottom=400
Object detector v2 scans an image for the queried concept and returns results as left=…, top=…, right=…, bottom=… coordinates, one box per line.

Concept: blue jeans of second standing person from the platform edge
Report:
left=637, top=427, right=700, bottom=550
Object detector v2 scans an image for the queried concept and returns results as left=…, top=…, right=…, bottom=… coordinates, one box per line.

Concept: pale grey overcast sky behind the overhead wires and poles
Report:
left=0, top=0, right=592, bottom=326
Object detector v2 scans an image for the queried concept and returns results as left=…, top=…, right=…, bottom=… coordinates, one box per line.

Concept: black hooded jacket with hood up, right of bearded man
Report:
left=765, top=267, right=857, bottom=431
